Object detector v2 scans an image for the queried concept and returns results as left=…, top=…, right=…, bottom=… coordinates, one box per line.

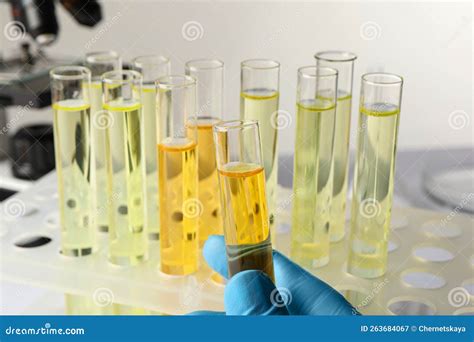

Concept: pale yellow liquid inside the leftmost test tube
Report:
left=53, top=100, right=96, bottom=256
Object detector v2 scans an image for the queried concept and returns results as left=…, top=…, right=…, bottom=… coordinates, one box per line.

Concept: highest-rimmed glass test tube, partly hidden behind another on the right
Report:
left=314, top=51, right=357, bottom=242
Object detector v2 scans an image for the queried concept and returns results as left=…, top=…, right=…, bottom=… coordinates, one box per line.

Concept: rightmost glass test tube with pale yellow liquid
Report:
left=348, top=73, right=403, bottom=278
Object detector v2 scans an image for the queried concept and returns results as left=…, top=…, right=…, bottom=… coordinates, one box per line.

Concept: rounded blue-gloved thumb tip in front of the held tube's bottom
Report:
left=224, top=270, right=288, bottom=316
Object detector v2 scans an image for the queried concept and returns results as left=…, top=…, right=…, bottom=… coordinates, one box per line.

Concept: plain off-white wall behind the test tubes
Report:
left=2, top=0, right=474, bottom=152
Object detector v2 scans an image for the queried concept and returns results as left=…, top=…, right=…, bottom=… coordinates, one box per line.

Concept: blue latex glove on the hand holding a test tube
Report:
left=194, top=235, right=359, bottom=315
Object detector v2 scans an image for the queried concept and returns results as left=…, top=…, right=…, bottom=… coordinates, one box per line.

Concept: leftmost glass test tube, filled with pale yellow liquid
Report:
left=50, top=66, right=96, bottom=256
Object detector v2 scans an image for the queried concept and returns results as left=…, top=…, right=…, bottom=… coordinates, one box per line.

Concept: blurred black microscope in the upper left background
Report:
left=0, top=0, right=102, bottom=180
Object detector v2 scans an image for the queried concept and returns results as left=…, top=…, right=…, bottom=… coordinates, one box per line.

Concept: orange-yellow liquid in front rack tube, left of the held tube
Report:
left=158, top=139, right=197, bottom=275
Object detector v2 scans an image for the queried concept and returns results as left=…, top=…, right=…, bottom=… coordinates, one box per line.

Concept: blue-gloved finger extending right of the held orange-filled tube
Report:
left=273, top=251, right=359, bottom=315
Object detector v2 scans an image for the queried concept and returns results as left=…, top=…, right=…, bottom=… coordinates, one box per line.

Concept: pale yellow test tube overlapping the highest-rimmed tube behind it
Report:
left=291, top=66, right=337, bottom=268
